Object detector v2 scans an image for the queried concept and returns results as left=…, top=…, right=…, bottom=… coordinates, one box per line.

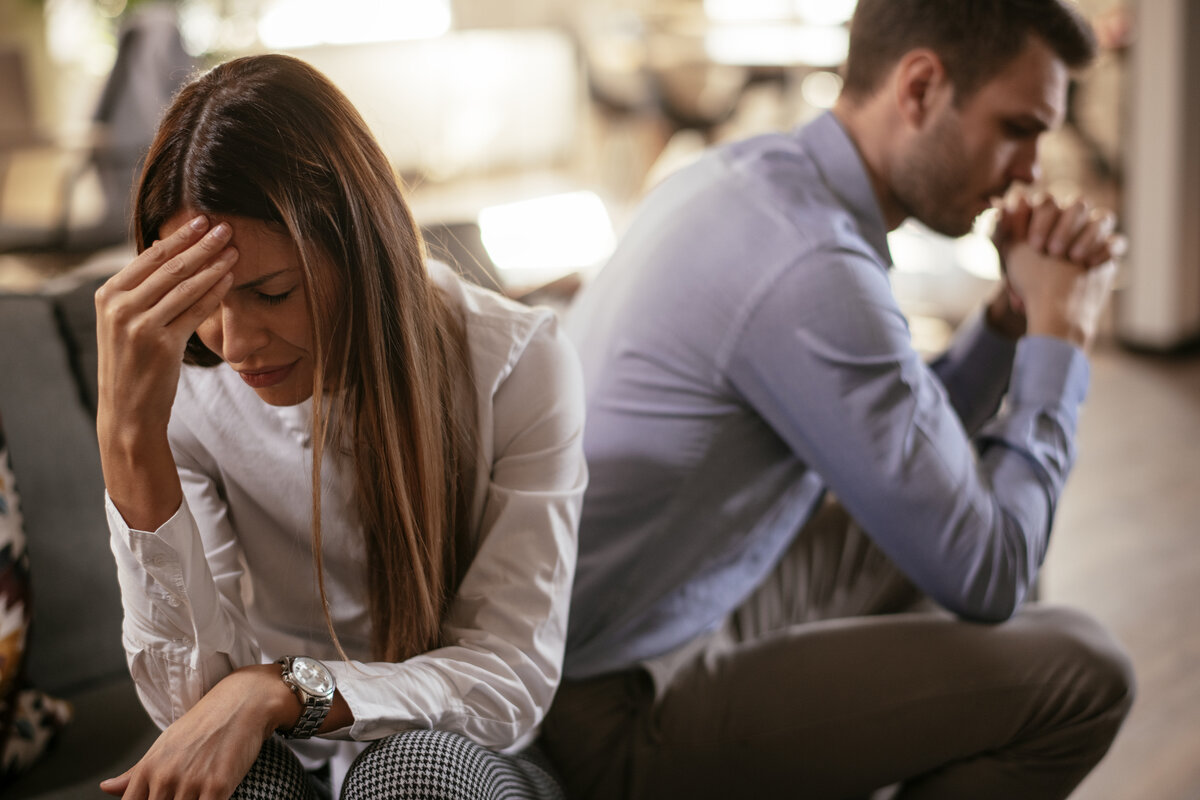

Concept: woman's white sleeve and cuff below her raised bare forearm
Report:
left=106, top=451, right=260, bottom=728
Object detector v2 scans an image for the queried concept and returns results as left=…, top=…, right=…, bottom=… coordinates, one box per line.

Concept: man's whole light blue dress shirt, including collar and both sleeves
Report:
left=565, top=114, right=1088, bottom=679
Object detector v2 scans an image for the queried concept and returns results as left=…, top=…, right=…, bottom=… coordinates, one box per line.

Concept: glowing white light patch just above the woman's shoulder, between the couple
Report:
left=479, top=192, right=617, bottom=275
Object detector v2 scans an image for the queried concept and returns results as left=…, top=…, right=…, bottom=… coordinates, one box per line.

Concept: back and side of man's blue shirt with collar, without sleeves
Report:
left=566, top=110, right=902, bottom=676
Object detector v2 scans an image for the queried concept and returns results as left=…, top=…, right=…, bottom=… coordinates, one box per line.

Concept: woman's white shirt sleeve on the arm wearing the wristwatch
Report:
left=329, top=316, right=587, bottom=750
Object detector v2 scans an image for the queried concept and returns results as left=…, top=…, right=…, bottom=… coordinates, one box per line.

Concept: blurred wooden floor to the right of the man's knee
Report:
left=1043, top=347, right=1200, bottom=800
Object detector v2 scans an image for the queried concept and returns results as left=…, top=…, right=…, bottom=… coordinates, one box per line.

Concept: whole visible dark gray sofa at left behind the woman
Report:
left=0, top=276, right=158, bottom=800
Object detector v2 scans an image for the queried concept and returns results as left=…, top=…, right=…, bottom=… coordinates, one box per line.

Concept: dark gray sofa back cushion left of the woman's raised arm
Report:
left=0, top=294, right=126, bottom=693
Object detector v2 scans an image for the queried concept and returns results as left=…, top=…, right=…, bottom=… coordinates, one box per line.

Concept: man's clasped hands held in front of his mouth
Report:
left=988, top=193, right=1123, bottom=348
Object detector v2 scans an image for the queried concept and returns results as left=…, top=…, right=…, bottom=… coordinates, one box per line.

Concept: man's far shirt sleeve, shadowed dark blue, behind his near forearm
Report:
left=929, top=312, right=1016, bottom=435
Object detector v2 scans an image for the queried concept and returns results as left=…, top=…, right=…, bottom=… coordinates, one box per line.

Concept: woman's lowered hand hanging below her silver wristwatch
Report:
left=100, top=664, right=300, bottom=800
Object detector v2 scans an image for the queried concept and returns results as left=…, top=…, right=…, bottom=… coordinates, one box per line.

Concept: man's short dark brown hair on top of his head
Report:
left=844, top=0, right=1096, bottom=103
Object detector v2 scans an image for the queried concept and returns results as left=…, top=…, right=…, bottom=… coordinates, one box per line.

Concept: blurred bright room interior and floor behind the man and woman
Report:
left=0, top=0, right=1200, bottom=800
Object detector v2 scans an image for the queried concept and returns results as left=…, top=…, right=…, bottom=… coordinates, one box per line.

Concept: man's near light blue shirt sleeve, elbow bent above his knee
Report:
left=726, top=251, right=1088, bottom=620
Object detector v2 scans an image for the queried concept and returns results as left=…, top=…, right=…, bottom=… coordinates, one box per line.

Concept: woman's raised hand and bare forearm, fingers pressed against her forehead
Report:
left=96, top=217, right=238, bottom=530
